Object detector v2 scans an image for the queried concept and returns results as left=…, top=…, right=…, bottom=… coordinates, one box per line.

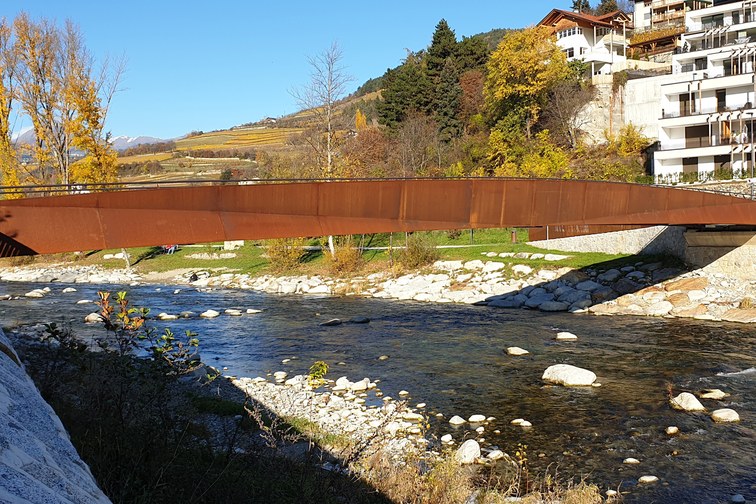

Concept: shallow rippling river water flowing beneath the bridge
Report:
left=0, top=283, right=756, bottom=503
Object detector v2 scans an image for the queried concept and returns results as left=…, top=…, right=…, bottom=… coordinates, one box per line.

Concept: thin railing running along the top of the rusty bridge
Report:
left=0, top=177, right=756, bottom=200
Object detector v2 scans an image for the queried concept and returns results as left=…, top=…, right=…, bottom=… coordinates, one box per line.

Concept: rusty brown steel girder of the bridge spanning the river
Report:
left=0, top=179, right=756, bottom=257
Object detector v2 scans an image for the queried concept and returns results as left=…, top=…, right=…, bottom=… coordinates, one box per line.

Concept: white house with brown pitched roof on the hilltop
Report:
left=538, top=9, right=632, bottom=75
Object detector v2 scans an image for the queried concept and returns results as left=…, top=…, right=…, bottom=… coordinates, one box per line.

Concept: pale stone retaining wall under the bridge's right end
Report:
left=530, top=226, right=685, bottom=258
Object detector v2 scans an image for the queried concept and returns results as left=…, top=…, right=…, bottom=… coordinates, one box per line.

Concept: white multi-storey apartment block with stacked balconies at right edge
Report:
left=654, top=0, right=756, bottom=183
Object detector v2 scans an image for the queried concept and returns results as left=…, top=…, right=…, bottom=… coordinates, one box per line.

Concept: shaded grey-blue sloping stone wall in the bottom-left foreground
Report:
left=0, top=330, right=110, bottom=504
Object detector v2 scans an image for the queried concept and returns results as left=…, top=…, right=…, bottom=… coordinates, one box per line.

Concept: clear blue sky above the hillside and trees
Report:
left=0, top=0, right=571, bottom=138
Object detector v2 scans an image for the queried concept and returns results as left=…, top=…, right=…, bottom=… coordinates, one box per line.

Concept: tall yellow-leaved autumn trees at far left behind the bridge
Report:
left=0, top=13, right=123, bottom=195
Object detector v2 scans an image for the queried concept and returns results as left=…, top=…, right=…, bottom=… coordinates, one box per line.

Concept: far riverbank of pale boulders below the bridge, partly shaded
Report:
left=0, top=252, right=756, bottom=323
